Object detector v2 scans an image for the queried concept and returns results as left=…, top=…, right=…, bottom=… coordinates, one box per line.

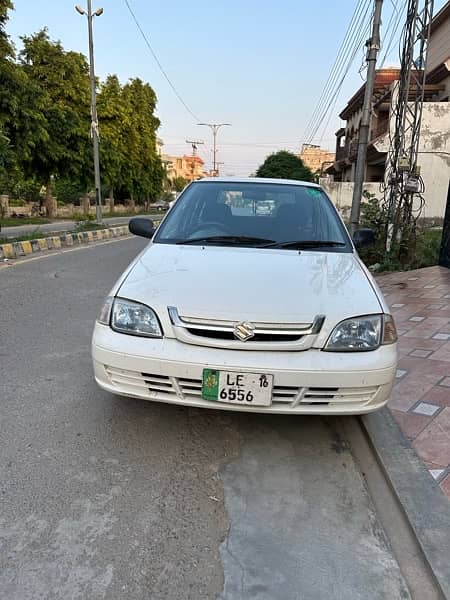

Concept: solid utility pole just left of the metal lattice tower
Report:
left=350, top=0, right=383, bottom=234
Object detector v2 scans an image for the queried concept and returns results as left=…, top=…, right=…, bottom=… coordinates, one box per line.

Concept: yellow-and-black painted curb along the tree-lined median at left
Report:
left=0, top=225, right=129, bottom=260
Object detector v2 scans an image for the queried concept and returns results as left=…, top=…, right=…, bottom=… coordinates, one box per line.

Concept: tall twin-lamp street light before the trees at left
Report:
left=75, top=0, right=103, bottom=223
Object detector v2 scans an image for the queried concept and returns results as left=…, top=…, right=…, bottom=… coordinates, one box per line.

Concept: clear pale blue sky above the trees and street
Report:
left=8, top=0, right=444, bottom=175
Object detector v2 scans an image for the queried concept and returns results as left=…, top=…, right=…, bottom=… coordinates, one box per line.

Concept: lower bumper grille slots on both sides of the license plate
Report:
left=105, top=367, right=378, bottom=408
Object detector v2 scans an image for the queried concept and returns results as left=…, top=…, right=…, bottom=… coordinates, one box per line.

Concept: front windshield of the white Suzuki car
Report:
left=154, top=181, right=352, bottom=252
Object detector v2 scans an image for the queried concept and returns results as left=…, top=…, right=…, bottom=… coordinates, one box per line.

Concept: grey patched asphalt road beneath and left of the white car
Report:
left=0, top=238, right=409, bottom=600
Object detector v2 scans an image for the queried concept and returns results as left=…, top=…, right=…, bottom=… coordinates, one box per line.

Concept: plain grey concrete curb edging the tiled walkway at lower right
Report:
left=361, top=408, right=450, bottom=600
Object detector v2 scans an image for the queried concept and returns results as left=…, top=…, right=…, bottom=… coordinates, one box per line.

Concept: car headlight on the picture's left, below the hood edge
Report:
left=111, top=298, right=162, bottom=337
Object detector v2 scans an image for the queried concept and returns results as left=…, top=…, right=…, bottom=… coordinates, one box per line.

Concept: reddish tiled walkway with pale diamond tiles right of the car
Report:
left=377, top=267, right=450, bottom=498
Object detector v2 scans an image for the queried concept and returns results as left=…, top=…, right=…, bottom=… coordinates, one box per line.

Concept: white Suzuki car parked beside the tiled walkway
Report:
left=92, top=178, right=397, bottom=415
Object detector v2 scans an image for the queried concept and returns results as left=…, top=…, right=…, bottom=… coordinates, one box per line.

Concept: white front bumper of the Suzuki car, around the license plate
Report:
left=92, top=323, right=397, bottom=415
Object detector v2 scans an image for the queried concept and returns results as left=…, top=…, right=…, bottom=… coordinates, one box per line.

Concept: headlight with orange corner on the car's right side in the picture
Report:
left=324, top=315, right=397, bottom=352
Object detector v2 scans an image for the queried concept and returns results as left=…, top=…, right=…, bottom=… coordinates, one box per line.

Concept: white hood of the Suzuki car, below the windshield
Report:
left=117, top=244, right=382, bottom=324
